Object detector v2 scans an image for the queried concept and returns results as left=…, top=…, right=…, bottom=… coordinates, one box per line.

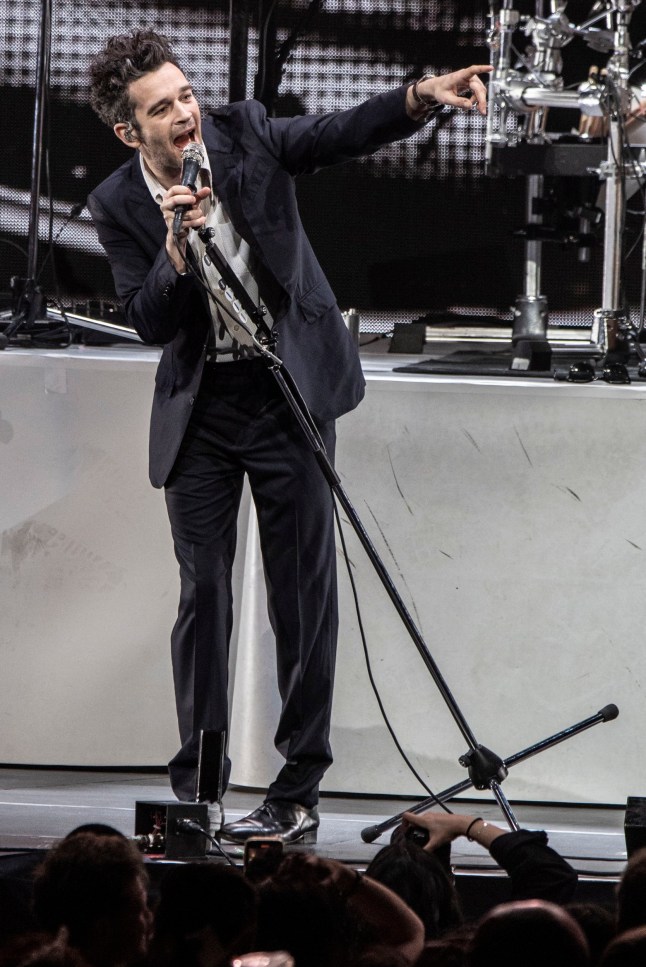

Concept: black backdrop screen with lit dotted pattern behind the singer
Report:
left=0, top=0, right=644, bottom=328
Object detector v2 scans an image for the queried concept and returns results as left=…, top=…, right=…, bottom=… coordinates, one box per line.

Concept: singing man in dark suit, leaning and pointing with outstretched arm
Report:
left=88, top=30, right=489, bottom=842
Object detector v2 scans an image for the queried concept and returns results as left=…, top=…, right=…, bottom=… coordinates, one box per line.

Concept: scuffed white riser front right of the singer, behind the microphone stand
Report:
left=233, top=373, right=646, bottom=803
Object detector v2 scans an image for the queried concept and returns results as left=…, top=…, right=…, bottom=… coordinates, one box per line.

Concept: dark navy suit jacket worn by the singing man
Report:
left=88, top=87, right=420, bottom=487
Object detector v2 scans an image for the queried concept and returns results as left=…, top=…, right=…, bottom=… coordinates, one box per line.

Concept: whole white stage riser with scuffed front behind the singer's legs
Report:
left=0, top=348, right=646, bottom=803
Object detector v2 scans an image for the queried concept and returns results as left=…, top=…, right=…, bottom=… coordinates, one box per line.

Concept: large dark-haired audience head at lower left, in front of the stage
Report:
left=34, top=832, right=151, bottom=967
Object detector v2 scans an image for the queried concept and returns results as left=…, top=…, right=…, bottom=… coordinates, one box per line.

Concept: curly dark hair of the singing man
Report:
left=90, top=30, right=179, bottom=127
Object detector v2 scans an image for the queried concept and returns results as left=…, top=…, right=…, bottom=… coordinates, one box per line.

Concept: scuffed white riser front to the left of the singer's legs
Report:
left=0, top=350, right=178, bottom=765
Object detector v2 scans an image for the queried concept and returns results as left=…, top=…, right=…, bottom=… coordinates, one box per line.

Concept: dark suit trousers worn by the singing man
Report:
left=166, top=360, right=338, bottom=807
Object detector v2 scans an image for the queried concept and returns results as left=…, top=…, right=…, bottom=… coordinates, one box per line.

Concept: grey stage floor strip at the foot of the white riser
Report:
left=0, top=767, right=626, bottom=915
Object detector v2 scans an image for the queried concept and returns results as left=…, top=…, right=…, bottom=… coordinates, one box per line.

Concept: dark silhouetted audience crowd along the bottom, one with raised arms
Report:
left=0, top=811, right=646, bottom=967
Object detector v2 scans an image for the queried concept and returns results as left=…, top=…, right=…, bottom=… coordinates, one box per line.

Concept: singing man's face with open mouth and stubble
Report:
left=121, top=63, right=202, bottom=188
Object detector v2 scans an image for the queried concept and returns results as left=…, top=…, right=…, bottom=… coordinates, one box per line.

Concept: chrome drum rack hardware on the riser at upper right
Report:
left=486, top=0, right=646, bottom=370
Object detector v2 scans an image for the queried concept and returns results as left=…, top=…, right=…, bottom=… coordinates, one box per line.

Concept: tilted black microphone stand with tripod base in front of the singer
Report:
left=198, top=228, right=619, bottom=843
